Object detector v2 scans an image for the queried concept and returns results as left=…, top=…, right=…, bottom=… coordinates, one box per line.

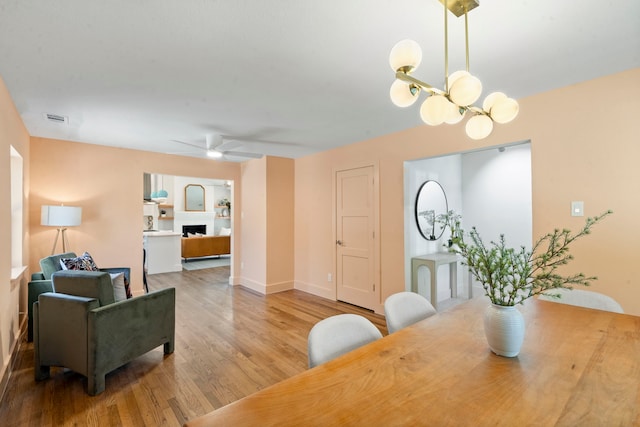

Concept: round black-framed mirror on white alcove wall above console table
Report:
left=415, top=181, right=449, bottom=240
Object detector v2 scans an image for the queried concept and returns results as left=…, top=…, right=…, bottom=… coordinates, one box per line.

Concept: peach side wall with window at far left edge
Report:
left=0, top=77, right=29, bottom=390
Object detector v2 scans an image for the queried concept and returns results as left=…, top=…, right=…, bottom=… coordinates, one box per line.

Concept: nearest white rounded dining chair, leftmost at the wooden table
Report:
left=307, top=314, right=382, bottom=368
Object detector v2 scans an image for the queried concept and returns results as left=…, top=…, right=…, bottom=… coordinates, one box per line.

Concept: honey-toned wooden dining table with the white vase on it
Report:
left=185, top=297, right=640, bottom=427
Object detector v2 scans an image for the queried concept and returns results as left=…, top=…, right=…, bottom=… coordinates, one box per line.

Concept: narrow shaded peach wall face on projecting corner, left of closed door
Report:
left=267, top=157, right=294, bottom=290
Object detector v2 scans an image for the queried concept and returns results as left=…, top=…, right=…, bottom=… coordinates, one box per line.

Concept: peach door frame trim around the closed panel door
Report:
left=331, top=160, right=384, bottom=313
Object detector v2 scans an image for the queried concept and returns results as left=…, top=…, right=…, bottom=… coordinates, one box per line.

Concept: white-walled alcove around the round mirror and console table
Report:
left=404, top=141, right=533, bottom=307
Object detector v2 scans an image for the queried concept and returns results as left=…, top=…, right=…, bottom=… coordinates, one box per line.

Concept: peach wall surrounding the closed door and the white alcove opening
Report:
left=295, top=69, right=640, bottom=315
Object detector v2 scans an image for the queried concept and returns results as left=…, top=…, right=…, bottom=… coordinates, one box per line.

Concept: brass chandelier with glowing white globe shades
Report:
left=389, top=0, right=519, bottom=140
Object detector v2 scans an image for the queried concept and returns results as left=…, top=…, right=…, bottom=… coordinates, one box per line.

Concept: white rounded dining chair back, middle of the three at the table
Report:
left=384, top=292, right=436, bottom=334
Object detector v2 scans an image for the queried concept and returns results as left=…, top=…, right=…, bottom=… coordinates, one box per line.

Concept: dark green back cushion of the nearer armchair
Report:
left=52, top=270, right=115, bottom=307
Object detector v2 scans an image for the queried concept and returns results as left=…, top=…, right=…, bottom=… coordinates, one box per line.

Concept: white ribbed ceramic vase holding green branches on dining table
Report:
left=484, top=304, right=524, bottom=357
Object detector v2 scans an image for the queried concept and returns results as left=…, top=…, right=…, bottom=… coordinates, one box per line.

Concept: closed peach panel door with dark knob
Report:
left=336, top=166, right=379, bottom=310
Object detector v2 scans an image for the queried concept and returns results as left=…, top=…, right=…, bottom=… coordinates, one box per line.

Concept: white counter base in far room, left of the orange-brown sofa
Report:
left=143, top=231, right=182, bottom=274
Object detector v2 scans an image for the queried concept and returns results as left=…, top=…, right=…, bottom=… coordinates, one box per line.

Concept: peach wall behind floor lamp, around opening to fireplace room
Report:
left=29, top=137, right=242, bottom=293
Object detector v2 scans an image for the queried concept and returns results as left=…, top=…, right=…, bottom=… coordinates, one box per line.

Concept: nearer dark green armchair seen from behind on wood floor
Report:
left=33, top=270, right=175, bottom=396
